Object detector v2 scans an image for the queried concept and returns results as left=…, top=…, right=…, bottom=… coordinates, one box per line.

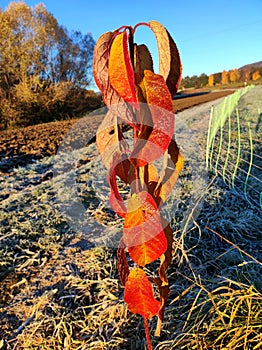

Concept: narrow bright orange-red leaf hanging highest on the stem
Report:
left=109, top=31, right=137, bottom=102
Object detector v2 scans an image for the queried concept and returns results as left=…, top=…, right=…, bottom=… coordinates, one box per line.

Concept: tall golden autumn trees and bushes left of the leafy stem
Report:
left=0, top=2, right=101, bottom=129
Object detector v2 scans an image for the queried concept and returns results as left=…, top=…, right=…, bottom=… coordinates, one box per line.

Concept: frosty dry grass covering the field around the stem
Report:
left=0, top=86, right=262, bottom=350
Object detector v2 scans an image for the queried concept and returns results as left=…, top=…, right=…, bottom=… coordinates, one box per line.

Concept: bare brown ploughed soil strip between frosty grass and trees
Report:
left=0, top=90, right=234, bottom=173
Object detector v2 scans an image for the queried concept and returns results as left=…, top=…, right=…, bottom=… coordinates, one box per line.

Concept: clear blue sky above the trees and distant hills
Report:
left=0, top=0, right=262, bottom=86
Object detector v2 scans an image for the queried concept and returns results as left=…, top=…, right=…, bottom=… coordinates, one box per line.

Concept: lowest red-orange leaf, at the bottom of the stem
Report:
left=124, top=268, right=160, bottom=319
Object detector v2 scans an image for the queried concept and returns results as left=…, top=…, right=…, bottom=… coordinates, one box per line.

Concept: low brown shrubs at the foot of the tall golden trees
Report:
left=0, top=82, right=101, bottom=129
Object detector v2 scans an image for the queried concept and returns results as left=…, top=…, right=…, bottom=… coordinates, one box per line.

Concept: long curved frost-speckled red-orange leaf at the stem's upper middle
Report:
left=131, top=70, right=175, bottom=166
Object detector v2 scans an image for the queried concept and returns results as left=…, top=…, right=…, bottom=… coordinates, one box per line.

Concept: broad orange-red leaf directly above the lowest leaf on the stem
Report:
left=123, top=191, right=167, bottom=266
